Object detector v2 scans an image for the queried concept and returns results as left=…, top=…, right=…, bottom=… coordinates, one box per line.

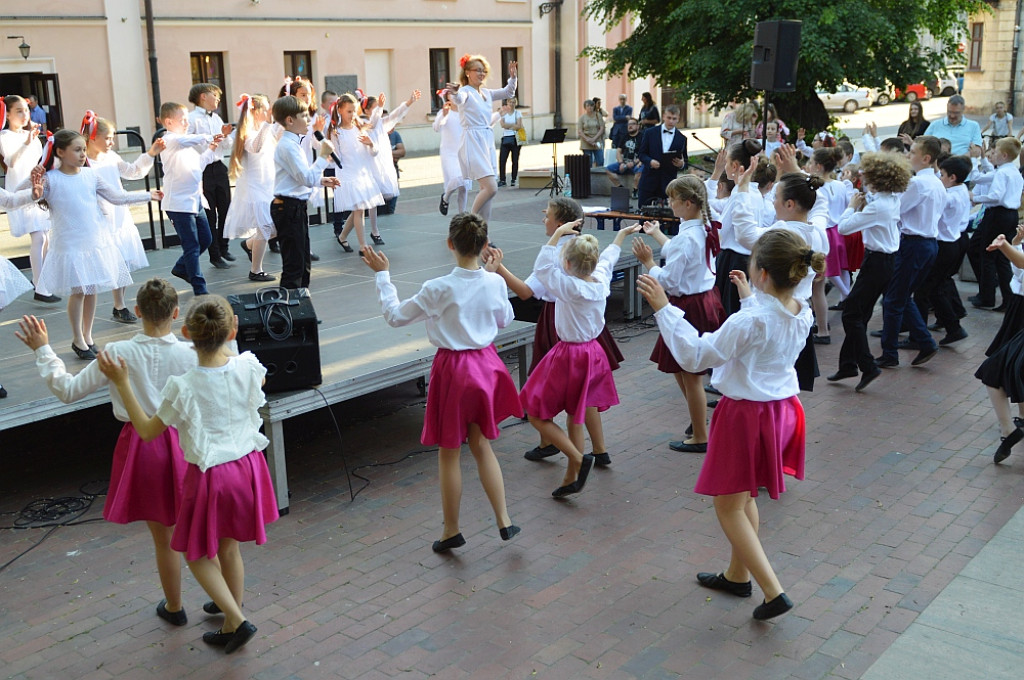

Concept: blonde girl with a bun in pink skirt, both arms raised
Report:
left=520, top=219, right=640, bottom=498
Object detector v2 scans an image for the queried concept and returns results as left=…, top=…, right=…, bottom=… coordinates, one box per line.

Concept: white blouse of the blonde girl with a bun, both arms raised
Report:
left=534, top=241, right=622, bottom=342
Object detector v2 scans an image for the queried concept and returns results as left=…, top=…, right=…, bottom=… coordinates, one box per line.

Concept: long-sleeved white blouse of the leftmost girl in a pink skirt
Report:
left=36, top=333, right=197, bottom=423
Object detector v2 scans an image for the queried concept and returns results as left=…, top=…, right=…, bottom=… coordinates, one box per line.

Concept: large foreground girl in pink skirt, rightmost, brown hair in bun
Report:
left=638, top=229, right=825, bottom=620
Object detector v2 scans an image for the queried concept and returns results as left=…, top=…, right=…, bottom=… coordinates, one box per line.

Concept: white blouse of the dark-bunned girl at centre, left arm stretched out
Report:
left=376, top=267, right=515, bottom=350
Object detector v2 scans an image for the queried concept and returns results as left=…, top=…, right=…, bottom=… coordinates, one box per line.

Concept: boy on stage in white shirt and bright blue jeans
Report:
left=160, top=101, right=224, bottom=295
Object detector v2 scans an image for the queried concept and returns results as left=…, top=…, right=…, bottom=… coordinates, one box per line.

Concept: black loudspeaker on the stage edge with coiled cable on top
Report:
left=227, top=288, right=324, bottom=393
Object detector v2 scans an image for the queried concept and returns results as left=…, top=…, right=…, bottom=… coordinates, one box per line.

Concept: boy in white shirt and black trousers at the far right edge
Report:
left=968, top=137, right=1024, bottom=311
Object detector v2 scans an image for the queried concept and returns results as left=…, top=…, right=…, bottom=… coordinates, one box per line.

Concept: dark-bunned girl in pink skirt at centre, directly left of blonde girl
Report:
left=362, top=213, right=522, bottom=553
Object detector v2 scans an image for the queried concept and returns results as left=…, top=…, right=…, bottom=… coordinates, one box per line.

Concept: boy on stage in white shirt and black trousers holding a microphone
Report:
left=270, top=94, right=341, bottom=288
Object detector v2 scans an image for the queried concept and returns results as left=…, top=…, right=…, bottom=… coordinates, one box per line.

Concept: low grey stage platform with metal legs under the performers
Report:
left=0, top=215, right=657, bottom=511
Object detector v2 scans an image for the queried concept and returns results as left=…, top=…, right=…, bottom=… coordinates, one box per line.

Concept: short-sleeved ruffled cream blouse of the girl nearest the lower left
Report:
left=156, top=352, right=270, bottom=472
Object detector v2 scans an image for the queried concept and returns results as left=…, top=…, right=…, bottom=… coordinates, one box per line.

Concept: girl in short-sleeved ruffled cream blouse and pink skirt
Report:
left=99, top=295, right=278, bottom=653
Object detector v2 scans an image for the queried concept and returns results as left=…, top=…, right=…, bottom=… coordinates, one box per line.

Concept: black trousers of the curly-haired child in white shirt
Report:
left=839, top=250, right=896, bottom=373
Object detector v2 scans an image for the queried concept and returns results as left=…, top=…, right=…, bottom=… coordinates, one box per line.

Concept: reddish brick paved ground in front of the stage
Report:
left=0, top=187, right=1024, bottom=680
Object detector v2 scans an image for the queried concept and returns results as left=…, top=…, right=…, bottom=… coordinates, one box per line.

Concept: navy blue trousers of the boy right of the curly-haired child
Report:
left=882, top=236, right=939, bottom=358
